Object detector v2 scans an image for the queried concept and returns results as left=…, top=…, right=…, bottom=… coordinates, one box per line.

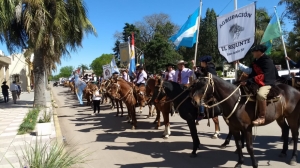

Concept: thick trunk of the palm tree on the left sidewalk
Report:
left=33, top=49, right=46, bottom=107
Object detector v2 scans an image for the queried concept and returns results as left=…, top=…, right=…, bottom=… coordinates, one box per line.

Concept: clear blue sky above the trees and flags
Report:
left=0, top=0, right=292, bottom=74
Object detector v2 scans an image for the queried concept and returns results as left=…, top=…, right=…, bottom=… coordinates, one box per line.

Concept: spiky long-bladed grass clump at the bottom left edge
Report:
left=10, top=140, right=90, bottom=168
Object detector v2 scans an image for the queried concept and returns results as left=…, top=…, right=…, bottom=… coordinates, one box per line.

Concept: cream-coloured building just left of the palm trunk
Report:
left=9, top=51, right=33, bottom=91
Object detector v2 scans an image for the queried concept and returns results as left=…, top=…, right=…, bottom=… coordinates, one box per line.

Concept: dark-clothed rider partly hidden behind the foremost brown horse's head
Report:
left=192, top=56, right=217, bottom=120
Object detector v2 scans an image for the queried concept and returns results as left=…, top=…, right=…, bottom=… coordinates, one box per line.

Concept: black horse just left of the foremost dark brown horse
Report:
left=153, top=78, right=222, bottom=157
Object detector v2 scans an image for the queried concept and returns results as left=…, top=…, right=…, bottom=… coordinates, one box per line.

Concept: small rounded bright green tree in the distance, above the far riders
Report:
left=90, top=54, right=114, bottom=76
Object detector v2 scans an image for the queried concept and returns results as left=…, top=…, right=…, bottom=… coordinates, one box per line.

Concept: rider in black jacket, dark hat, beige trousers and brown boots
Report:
left=241, top=45, right=276, bottom=126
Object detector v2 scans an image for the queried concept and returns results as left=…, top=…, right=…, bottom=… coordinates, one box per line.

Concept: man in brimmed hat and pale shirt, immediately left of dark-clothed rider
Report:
left=174, top=60, right=193, bottom=84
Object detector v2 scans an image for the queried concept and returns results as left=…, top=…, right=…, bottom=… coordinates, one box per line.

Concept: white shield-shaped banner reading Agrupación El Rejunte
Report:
left=217, top=3, right=255, bottom=62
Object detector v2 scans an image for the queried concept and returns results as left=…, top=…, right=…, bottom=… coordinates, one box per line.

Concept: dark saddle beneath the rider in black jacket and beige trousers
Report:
left=242, top=83, right=282, bottom=102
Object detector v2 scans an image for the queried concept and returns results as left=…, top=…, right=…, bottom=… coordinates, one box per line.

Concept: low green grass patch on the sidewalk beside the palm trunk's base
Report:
left=18, top=108, right=40, bottom=135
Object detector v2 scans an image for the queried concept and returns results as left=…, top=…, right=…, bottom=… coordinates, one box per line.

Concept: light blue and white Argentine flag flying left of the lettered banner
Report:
left=169, top=8, right=200, bottom=49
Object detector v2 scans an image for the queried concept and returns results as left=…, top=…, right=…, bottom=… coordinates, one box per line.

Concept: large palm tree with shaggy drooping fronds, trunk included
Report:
left=0, top=0, right=96, bottom=106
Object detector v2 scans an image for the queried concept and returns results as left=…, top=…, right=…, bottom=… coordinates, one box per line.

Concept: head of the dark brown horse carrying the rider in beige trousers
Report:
left=190, top=73, right=214, bottom=106
